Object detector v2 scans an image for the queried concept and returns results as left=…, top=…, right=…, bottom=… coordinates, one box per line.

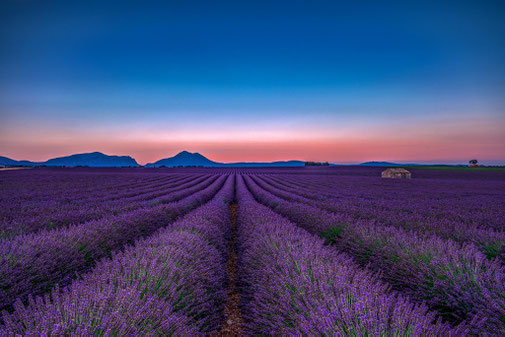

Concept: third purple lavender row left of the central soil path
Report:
left=0, top=175, right=211, bottom=236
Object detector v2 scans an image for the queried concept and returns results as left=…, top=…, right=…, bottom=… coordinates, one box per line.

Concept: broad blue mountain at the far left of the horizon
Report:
left=0, top=152, right=140, bottom=167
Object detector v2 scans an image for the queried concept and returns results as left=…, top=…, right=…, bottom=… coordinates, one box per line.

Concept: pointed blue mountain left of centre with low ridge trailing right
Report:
left=146, top=151, right=305, bottom=167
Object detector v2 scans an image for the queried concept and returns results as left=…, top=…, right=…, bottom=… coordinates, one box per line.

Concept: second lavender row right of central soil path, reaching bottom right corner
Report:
left=246, top=178, right=505, bottom=335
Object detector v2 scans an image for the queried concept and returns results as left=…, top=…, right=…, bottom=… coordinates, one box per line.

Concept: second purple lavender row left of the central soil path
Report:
left=0, top=176, right=226, bottom=308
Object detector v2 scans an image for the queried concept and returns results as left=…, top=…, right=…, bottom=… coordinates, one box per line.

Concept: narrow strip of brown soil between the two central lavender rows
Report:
left=212, top=203, right=243, bottom=337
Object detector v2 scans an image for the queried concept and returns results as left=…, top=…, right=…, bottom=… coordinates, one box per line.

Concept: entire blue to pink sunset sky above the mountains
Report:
left=0, top=0, right=505, bottom=164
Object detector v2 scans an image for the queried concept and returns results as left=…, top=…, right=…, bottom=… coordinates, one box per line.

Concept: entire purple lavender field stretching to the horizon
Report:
left=0, top=167, right=505, bottom=336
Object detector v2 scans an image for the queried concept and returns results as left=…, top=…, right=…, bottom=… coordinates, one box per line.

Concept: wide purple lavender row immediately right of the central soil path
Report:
left=237, top=177, right=458, bottom=336
